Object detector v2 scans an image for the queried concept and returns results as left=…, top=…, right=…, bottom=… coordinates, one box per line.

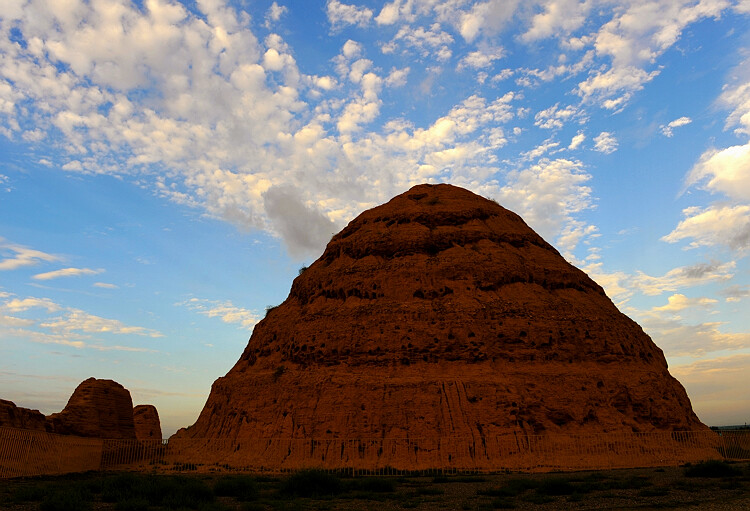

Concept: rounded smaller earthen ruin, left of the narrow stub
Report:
left=47, top=378, right=136, bottom=439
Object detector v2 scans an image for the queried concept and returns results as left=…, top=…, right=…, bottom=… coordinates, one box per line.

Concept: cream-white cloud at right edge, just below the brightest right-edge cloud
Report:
left=662, top=204, right=750, bottom=252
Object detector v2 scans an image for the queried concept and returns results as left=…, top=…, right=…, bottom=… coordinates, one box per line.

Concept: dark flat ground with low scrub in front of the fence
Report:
left=0, top=462, right=750, bottom=511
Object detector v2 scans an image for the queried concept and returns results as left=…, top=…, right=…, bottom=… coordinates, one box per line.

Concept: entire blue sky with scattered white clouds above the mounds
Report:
left=0, top=0, right=750, bottom=435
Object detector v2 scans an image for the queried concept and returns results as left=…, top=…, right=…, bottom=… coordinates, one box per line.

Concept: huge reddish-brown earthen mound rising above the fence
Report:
left=178, top=185, right=720, bottom=469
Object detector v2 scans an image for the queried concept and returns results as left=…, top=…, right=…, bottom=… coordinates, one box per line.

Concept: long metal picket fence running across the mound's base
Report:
left=0, top=428, right=750, bottom=478
